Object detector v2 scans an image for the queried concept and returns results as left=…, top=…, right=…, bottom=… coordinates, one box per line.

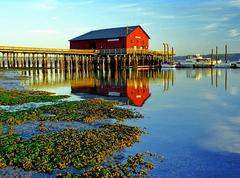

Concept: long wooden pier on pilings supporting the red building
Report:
left=0, top=46, right=176, bottom=70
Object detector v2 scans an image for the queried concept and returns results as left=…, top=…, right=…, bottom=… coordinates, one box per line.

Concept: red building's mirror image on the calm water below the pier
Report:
left=71, top=78, right=150, bottom=107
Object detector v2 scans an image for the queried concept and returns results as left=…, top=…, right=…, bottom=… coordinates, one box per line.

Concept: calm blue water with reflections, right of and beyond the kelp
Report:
left=3, top=69, right=240, bottom=177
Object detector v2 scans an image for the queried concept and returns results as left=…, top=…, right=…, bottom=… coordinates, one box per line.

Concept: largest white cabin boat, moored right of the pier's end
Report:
left=180, top=54, right=222, bottom=68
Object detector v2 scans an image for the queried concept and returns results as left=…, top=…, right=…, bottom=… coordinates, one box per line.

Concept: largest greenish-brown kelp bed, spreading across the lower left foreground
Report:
left=0, top=124, right=142, bottom=174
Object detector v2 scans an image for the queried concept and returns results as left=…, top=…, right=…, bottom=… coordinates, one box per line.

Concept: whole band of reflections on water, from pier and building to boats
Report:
left=22, top=68, right=234, bottom=107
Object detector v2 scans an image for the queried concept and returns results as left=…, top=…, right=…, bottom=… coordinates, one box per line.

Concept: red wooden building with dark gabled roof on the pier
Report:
left=69, top=25, right=150, bottom=50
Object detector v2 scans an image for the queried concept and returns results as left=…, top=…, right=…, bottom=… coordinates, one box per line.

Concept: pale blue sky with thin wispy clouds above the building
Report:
left=0, top=0, right=240, bottom=55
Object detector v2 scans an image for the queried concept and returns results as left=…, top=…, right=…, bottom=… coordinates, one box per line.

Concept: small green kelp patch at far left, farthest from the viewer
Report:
left=0, top=88, right=69, bottom=105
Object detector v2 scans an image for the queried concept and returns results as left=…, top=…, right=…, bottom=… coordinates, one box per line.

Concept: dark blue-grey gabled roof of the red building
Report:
left=70, top=25, right=150, bottom=41
